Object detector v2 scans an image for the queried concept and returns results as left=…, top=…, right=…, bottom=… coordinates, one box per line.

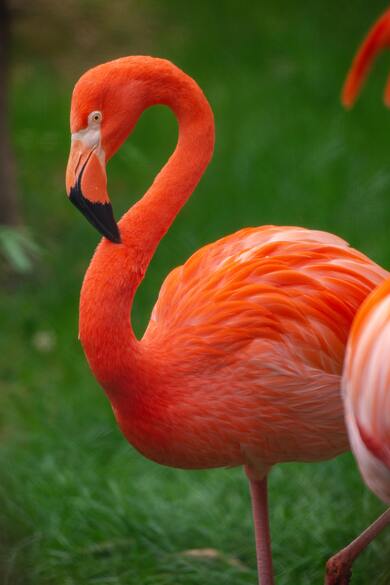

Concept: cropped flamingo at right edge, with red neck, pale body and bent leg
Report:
left=326, top=10, right=390, bottom=585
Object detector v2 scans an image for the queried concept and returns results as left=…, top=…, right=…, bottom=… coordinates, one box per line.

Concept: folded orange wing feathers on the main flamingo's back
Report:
left=144, top=226, right=387, bottom=372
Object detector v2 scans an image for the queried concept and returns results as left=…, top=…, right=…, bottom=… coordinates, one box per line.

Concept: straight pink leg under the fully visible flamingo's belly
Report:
left=247, top=472, right=274, bottom=585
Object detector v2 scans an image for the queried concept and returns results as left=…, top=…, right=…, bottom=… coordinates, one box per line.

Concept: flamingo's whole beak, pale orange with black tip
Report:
left=66, top=138, right=121, bottom=244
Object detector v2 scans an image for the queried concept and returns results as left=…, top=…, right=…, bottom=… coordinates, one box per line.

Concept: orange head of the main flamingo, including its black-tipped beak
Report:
left=66, top=57, right=148, bottom=243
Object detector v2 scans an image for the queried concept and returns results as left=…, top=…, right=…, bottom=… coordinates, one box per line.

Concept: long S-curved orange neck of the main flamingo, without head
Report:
left=80, top=58, right=214, bottom=408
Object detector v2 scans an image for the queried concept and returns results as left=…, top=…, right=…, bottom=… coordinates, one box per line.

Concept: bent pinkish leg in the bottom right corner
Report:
left=325, top=508, right=390, bottom=585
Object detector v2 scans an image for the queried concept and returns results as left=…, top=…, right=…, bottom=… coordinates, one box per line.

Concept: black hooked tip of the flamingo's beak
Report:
left=69, top=182, right=122, bottom=244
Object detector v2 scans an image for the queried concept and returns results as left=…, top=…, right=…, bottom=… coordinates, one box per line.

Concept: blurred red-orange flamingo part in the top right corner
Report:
left=341, top=10, right=390, bottom=108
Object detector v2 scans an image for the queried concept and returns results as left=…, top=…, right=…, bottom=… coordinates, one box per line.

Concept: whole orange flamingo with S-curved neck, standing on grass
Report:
left=66, top=56, right=389, bottom=585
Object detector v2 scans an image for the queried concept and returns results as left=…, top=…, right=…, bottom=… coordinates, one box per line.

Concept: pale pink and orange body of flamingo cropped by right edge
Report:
left=343, top=281, right=390, bottom=503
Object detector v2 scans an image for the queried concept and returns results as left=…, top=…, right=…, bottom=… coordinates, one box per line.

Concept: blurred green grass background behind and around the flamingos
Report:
left=0, top=0, right=390, bottom=585
